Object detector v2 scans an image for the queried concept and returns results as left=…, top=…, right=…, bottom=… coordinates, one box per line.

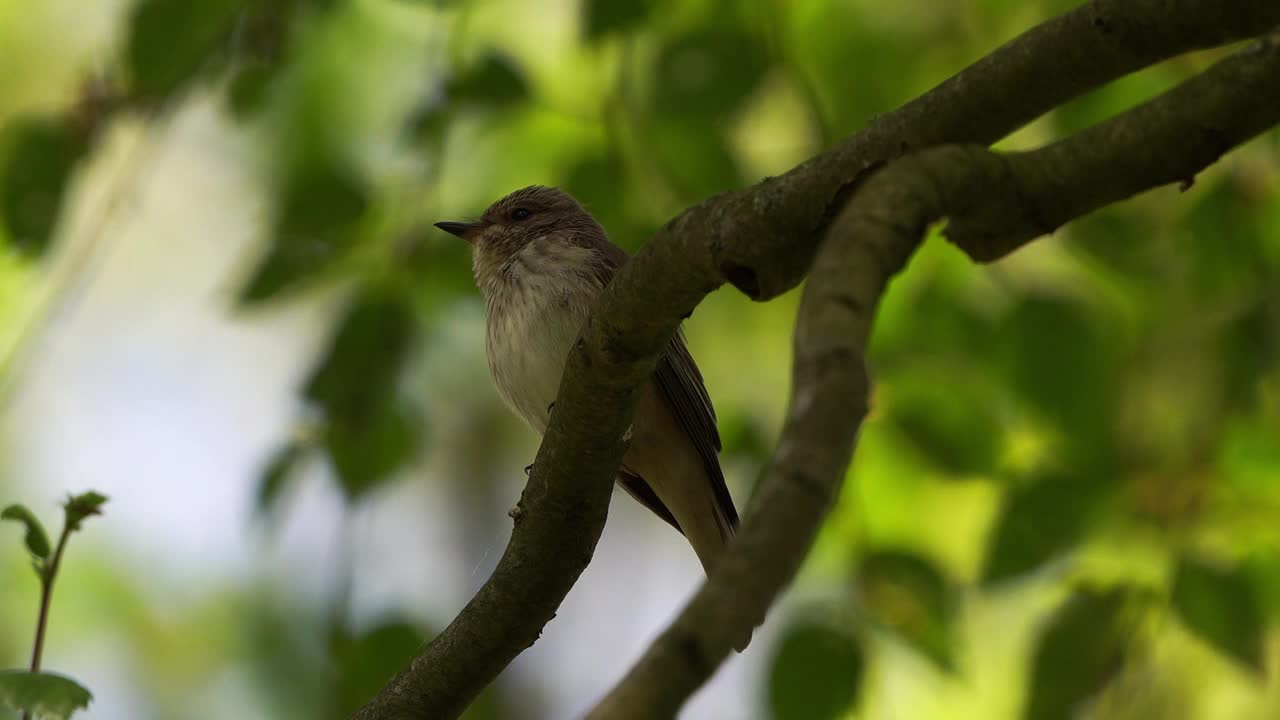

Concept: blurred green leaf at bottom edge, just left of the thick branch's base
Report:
left=332, top=620, right=425, bottom=717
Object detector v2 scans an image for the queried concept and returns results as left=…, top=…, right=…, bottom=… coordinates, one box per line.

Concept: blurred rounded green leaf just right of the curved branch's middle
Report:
left=888, top=382, right=1004, bottom=475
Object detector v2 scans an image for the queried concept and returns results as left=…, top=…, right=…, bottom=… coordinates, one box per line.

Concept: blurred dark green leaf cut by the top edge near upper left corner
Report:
left=125, top=0, right=244, bottom=101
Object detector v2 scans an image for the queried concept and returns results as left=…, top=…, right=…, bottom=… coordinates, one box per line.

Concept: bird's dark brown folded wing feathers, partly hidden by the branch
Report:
left=588, top=240, right=737, bottom=532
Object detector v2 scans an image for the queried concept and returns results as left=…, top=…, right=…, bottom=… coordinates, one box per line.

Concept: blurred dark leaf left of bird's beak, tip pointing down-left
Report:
left=241, top=163, right=370, bottom=302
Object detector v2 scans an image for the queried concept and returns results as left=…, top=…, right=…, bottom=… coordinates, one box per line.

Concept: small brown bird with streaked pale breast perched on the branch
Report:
left=435, top=186, right=745, bottom=576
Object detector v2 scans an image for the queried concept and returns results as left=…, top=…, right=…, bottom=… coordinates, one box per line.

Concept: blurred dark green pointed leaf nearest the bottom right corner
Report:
left=1172, top=555, right=1267, bottom=673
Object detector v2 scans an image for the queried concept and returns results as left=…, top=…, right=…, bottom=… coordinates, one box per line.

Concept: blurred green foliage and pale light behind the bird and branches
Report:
left=0, top=0, right=1280, bottom=720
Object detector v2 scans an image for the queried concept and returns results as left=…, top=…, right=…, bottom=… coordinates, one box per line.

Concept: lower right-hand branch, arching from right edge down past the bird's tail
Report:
left=590, top=33, right=1280, bottom=720
